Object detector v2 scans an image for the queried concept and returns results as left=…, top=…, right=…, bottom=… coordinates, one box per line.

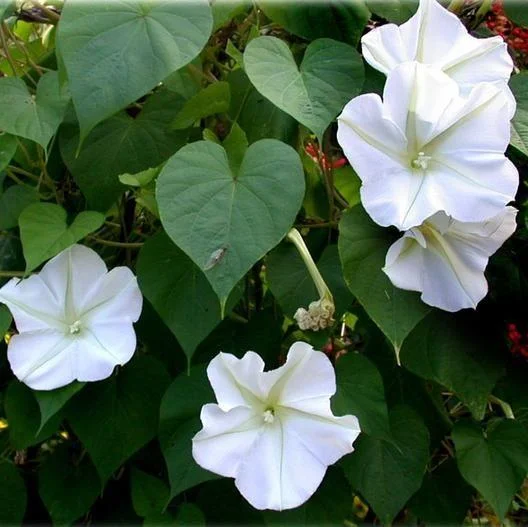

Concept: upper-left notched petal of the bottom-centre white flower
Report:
left=207, top=351, right=266, bottom=411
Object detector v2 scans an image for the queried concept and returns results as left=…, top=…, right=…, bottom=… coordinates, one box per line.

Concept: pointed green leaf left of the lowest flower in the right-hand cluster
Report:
left=339, top=205, right=430, bottom=355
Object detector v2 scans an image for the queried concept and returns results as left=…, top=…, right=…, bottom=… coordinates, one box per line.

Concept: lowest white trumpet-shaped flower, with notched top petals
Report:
left=192, top=342, right=360, bottom=510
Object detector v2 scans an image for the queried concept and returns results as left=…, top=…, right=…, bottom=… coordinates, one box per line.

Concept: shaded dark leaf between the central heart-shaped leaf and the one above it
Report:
left=227, top=69, right=299, bottom=145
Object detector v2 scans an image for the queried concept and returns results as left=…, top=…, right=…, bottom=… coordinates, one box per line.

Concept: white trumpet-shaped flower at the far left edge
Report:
left=0, top=245, right=143, bottom=390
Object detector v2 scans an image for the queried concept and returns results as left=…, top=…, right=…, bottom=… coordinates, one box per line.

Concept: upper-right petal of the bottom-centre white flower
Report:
left=264, top=342, right=336, bottom=406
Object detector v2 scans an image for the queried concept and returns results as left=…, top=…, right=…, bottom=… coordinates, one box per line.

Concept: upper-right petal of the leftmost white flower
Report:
left=78, top=267, right=143, bottom=324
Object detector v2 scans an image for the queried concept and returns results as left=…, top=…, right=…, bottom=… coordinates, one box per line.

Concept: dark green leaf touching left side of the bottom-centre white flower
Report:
left=159, top=365, right=218, bottom=498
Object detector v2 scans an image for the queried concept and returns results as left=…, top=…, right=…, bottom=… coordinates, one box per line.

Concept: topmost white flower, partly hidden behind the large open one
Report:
left=361, top=0, right=515, bottom=107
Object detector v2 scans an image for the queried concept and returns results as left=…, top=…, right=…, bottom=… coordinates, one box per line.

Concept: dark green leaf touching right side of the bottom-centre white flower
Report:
left=332, top=352, right=390, bottom=439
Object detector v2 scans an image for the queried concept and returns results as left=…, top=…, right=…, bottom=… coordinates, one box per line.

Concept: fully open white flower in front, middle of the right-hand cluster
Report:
left=337, top=62, right=519, bottom=230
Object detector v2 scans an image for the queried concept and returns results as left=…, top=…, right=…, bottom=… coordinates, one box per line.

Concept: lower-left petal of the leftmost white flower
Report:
left=7, top=330, right=77, bottom=390
